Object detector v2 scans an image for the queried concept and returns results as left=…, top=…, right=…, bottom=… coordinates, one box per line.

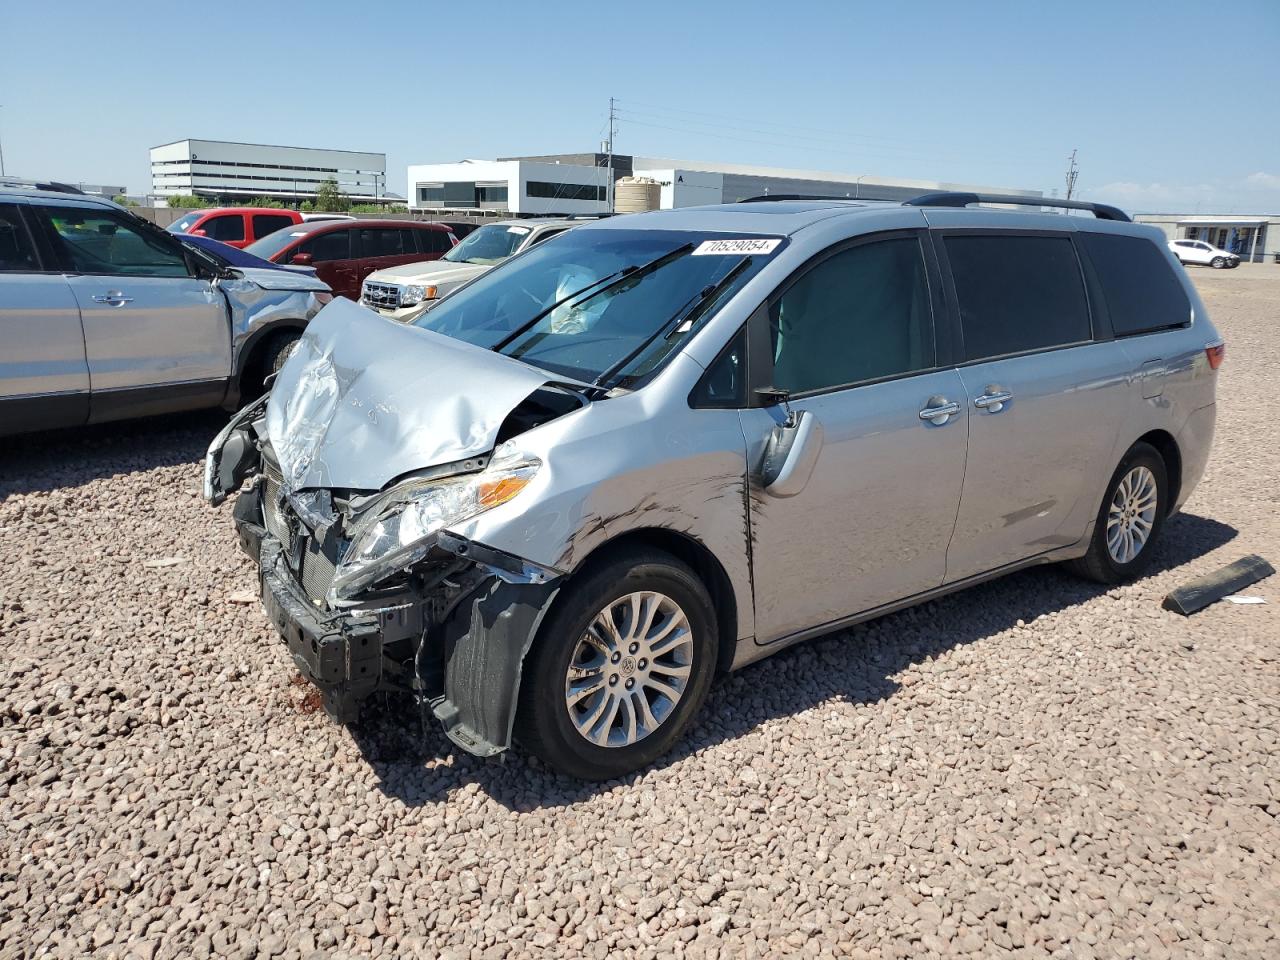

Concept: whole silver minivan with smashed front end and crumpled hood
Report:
left=205, top=193, right=1224, bottom=778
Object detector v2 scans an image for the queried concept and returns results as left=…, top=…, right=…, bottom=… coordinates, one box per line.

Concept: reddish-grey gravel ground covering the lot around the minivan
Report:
left=0, top=265, right=1280, bottom=957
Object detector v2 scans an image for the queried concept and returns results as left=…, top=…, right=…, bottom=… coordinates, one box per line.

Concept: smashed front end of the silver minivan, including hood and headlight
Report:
left=205, top=301, right=576, bottom=755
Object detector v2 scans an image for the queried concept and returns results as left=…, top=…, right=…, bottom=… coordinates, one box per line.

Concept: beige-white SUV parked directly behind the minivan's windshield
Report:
left=360, top=220, right=577, bottom=321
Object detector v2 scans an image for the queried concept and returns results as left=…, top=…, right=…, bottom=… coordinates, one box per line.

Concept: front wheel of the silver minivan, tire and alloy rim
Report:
left=517, top=549, right=717, bottom=780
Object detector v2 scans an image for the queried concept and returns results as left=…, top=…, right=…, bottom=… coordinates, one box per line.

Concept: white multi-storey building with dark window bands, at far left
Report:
left=151, top=140, right=387, bottom=205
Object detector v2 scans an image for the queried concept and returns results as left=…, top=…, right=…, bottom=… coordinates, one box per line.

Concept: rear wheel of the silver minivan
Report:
left=1069, top=443, right=1169, bottom=584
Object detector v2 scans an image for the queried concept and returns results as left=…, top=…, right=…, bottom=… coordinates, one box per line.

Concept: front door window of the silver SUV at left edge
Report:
left=41, top=205, right=189, bottom=276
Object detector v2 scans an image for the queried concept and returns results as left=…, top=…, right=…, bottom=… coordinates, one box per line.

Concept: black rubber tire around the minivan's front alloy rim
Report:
left=516, top=549, right=718, bottom=780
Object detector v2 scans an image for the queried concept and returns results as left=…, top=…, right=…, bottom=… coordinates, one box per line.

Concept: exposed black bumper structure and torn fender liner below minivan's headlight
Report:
left=236, top=492, right=561, bottom=756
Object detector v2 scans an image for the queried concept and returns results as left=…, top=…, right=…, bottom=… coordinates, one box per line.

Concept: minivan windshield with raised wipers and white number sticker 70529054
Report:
left=415, top=228, right=782, bottom=385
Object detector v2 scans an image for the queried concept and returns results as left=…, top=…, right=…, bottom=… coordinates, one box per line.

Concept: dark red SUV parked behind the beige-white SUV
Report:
left=247, top=220, right=457, bottom=300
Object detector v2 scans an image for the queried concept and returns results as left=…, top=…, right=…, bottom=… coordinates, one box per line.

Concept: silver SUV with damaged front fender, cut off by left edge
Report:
left=0, top=188, right=332, bottom=434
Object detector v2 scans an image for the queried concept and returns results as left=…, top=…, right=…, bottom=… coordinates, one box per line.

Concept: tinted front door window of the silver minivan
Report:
left=769, top=237, right=933, bottom=393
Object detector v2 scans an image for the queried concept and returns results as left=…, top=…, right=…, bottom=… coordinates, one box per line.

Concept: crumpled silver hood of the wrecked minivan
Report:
left=266, top=298, right=548, bottom=493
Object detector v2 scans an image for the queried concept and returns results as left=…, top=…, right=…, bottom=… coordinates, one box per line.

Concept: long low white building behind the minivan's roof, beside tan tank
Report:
left=408, top=154, right=1043, bottom=215
